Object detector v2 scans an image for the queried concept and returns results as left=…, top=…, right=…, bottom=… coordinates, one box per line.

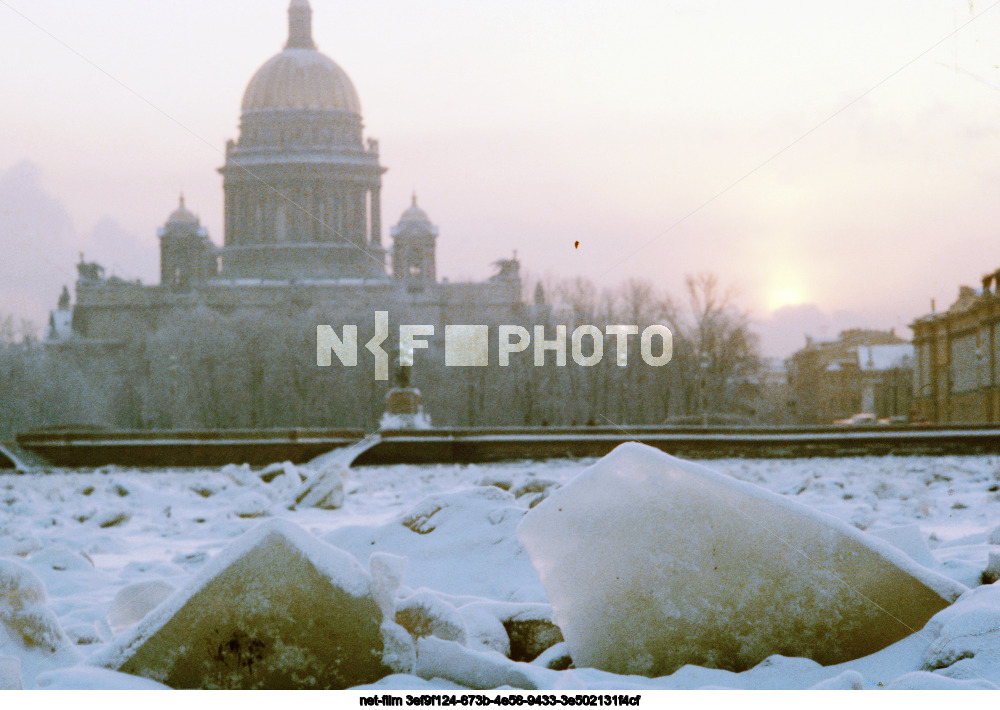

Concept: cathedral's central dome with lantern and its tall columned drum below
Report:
left=221, top=0, right=386, bottom=279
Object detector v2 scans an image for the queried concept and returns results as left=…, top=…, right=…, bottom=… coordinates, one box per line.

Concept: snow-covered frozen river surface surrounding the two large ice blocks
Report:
left=0, top=456, right=1000, bottom=688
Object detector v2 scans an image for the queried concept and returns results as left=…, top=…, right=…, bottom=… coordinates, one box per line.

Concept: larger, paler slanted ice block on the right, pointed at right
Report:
left=518, top=443, right=965, bottom=676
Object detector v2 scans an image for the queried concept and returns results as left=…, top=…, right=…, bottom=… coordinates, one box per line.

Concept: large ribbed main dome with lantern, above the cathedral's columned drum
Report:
left=243, top=0, right=361, bottom=114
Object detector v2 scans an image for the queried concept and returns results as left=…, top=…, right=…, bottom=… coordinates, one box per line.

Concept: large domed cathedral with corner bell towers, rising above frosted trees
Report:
left=54, top=0, right=524, bottom=346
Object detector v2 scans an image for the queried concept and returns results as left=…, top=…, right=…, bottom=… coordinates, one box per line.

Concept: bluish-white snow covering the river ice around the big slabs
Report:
left=0, top=452, right=1000, bottom=691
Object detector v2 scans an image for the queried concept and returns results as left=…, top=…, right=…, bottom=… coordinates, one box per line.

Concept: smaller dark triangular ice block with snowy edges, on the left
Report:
left=97, top=520, right=398, bottom=689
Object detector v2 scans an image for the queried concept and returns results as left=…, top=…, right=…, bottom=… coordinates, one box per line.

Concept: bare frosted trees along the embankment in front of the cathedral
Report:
left=0, top=274, right=783, bottom=437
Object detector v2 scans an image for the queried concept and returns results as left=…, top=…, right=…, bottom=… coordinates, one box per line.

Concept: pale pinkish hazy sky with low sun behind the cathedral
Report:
left=0, top=0, right=1000, bottom=355
